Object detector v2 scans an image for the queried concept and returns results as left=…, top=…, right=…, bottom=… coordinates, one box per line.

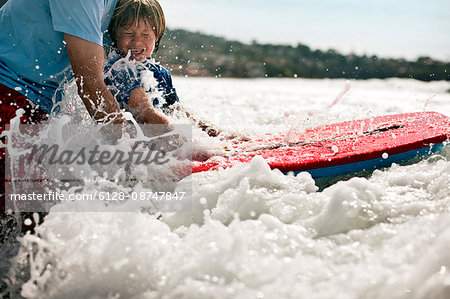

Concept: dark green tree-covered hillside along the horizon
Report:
left=155, top=29, right=450, bottom=81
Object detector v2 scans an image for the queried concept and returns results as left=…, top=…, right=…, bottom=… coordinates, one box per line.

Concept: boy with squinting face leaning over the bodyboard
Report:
left=105, top=0, right=219, bottom=136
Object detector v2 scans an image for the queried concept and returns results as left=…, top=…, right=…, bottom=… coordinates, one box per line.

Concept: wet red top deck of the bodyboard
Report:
left=193, top=112, right=450, bottom=177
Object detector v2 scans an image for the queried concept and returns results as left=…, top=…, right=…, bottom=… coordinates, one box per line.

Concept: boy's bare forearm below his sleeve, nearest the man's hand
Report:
left=128, top=87, right=169, bottom=125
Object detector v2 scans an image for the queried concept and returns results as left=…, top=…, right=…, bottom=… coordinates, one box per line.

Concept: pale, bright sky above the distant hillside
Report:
left=159, top=0, right=450, bottom=61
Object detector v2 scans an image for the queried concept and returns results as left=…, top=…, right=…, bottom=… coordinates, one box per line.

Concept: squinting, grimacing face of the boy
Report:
left=116, top=20, right=156, bottom=61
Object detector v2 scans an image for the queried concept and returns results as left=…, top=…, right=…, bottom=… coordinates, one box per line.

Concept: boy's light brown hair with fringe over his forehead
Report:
left=108, top=0, right=166, bottom=52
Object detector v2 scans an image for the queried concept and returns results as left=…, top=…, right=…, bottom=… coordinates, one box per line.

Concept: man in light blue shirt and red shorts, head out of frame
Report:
left=0, top=0, right=124, bottom=234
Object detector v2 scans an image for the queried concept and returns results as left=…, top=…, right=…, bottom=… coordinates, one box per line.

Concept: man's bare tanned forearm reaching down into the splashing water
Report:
left=64, top=34, right=124, bottom=123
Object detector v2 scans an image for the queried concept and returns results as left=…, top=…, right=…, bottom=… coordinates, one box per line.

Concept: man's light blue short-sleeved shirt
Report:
left=0, top=0, right=117, bottom=113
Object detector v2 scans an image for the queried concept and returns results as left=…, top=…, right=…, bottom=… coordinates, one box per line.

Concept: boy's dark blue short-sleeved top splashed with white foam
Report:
left=104, top=52, right=179, bottom=109
